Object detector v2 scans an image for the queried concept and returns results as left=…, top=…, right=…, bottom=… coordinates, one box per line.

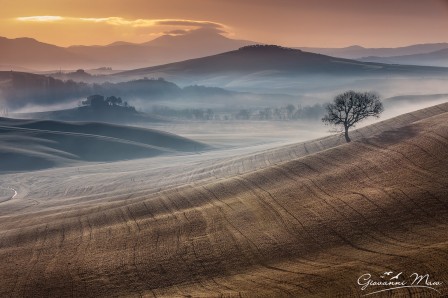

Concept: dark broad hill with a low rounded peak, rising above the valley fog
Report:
left=112, top=45, right=448, bottom=86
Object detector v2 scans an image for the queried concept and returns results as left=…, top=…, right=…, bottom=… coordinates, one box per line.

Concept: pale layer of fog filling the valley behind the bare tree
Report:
left=1, top=75, right=448, bottom=151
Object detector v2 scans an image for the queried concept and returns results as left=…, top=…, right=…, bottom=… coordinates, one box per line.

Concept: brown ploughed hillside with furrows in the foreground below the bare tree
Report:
left=0, top=103, right=448, bottom=297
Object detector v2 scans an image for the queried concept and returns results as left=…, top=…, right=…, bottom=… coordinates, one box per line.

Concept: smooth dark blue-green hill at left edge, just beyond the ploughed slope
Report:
left=0, top=118, right=207, bottom=172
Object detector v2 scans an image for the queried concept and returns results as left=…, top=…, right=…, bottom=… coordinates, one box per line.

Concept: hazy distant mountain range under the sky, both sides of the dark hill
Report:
left=0, top=29, right=448, bottom=72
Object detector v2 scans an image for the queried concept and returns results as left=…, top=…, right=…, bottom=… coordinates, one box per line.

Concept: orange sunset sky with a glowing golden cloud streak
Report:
left=0, top=0, right=448, bottom=47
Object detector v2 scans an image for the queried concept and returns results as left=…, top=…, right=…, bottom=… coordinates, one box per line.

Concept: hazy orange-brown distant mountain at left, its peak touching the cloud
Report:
left=0, top=30, right=254, bottom=70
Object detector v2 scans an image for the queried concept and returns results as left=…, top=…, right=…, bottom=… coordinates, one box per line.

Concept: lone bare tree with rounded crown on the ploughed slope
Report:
left=322, top=90, right=384, bottom=143
